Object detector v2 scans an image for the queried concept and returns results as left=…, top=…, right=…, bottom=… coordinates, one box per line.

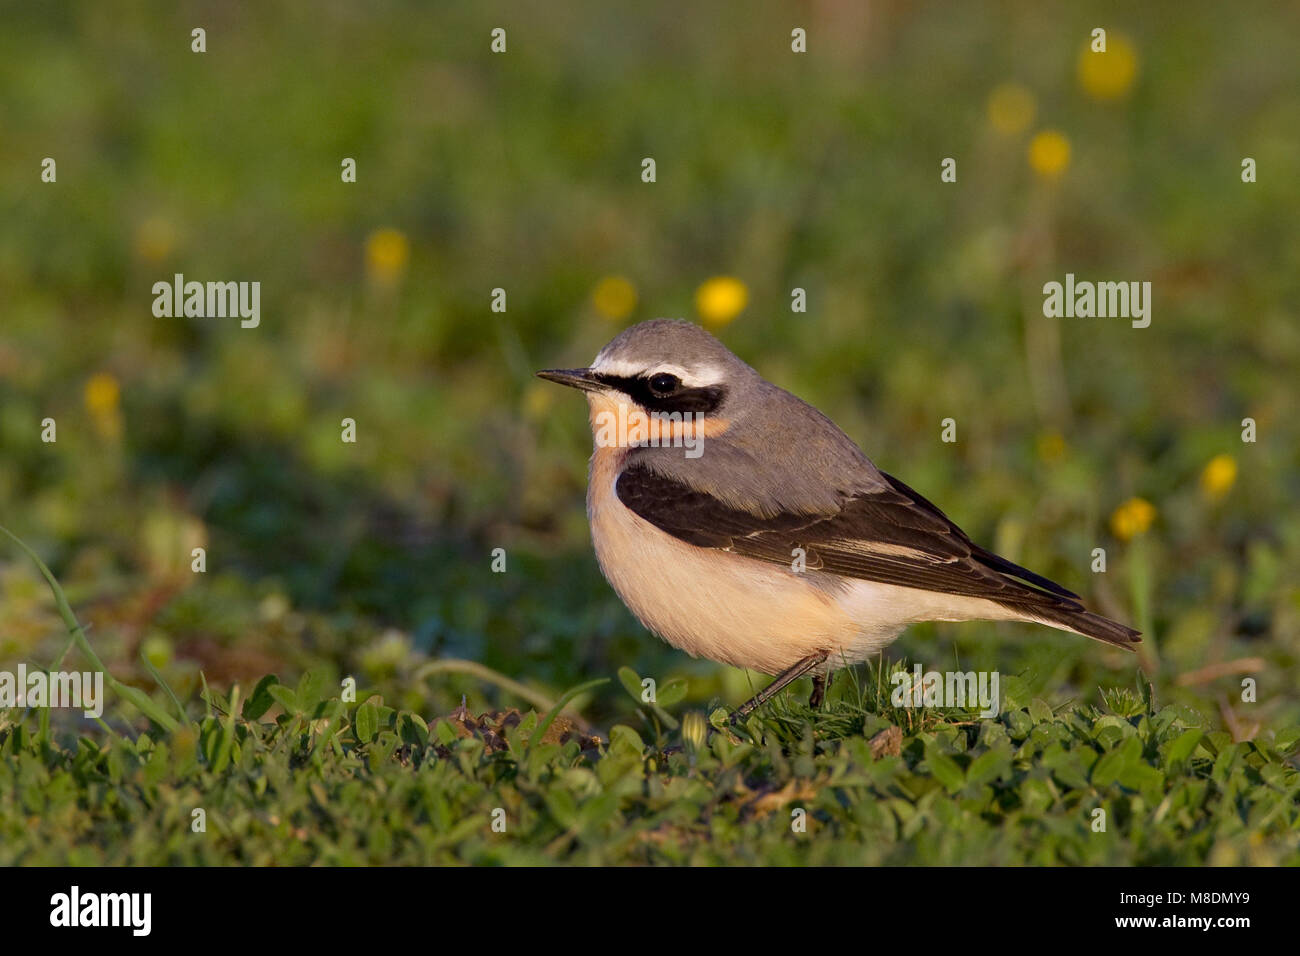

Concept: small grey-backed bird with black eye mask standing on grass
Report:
left=537, top=319, right=1141, bottom=713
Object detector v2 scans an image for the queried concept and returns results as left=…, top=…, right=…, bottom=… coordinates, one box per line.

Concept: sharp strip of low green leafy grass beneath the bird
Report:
left=0, top=530, right=1300, bottom=865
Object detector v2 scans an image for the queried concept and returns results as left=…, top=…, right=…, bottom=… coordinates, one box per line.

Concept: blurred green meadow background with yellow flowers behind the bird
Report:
left=0, top=1, right=1300, bottom=735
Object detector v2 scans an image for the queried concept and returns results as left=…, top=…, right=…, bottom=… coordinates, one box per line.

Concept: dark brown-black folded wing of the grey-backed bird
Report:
left=615, top=464, right=1083, bottom=611
